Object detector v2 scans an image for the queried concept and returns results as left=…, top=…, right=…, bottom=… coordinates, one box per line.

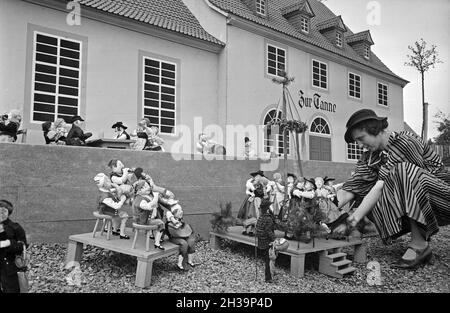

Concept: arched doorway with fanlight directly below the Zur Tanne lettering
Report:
left=309, top=117, right=331, bottom=161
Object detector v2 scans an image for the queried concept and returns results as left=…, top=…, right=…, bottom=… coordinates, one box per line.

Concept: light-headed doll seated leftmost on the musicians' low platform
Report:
left=94, top=173, right=130, bottom=239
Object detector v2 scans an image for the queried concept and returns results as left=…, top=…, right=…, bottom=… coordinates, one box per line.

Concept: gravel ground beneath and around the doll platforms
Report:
left=28, top=226, right=450, bottom=293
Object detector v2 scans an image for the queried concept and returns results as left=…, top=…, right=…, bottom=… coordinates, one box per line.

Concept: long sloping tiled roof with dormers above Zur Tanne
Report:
left=209, top=0, right=406, bottom=82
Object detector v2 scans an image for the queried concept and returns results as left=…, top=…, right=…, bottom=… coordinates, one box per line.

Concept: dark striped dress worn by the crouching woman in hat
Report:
left=342, top=132, right=450, bottom=243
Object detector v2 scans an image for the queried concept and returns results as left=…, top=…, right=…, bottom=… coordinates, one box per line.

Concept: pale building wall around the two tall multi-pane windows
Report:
left=0, top=0, right=218, bottom=149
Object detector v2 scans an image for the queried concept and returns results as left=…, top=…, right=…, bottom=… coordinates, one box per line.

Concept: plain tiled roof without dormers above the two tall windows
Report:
left=75, top=0, right=225, bottom=46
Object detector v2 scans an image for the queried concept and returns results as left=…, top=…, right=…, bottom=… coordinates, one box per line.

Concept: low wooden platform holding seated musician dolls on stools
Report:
left=66, top=228, right=179, bottom=288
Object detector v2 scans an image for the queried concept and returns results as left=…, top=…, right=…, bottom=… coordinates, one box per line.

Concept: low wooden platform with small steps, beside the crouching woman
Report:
left=209, top=226, right=366, bottom=277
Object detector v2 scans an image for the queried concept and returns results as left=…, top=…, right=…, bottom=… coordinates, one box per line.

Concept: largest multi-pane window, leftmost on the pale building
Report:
left=31, top=32, right=82, bottom=122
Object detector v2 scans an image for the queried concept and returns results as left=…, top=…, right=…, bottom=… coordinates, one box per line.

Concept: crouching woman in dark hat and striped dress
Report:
left=337, top=109, right=450, bottom=268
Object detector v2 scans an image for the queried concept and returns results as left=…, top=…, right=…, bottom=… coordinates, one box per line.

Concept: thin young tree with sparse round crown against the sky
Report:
left=405, top=38, right=443, bottom=141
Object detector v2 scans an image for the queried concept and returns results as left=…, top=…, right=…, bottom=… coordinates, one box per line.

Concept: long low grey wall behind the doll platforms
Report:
left=0, top=143, right=353, bottom=244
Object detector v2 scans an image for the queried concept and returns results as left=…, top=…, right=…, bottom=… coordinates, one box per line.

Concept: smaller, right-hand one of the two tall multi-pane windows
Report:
left=143, top=57, right=176, bottom=134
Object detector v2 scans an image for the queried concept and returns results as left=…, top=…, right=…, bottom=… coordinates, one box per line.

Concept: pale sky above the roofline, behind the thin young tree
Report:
left=322, top=0, right=450, bottom=138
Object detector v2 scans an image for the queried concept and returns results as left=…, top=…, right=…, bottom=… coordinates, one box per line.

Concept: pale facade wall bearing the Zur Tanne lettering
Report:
left=227, top=26, right=403, bottom=162
